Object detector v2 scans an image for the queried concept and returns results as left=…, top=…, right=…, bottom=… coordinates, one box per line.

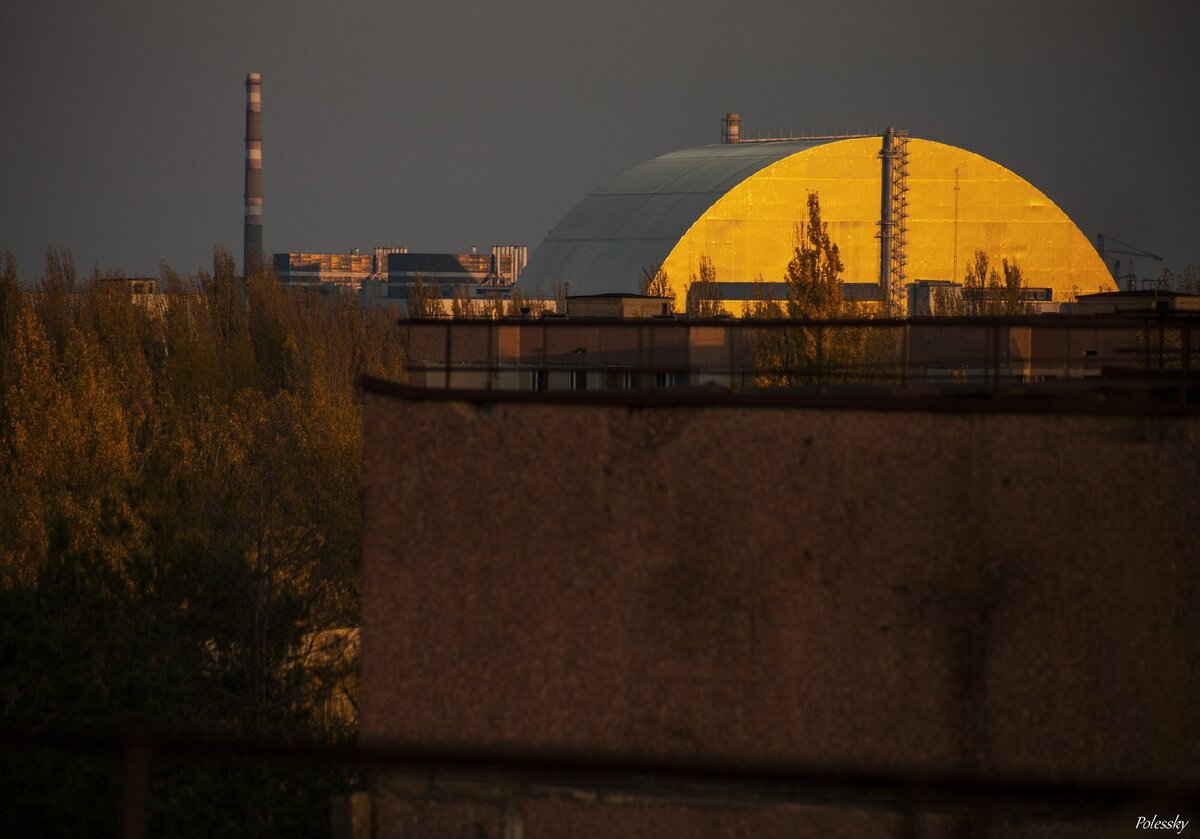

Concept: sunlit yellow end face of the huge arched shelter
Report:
left=662, top=138, right=1115, bottom=312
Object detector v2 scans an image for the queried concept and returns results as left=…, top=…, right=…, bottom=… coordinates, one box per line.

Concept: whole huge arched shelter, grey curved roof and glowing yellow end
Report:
left=521, top=123, right=1115, bottom=313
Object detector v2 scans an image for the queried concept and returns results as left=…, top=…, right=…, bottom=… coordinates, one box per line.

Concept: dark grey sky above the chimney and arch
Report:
left=0, top=0, right=1200, bottom=276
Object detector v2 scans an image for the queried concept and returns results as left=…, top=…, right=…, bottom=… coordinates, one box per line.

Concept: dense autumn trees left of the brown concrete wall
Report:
left=0, top=251, right=402, bottom=837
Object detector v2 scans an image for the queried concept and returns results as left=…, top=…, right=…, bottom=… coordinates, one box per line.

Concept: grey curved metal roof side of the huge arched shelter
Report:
left=520, top=140, right=829, bottom=295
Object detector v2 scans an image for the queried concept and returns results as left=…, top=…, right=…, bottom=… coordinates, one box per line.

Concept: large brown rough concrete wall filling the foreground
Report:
left=361, top=392, right=1200, bottom=837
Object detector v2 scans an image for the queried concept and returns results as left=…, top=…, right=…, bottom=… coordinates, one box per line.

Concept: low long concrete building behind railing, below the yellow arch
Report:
left=402, top=309, right=1200, bottom=398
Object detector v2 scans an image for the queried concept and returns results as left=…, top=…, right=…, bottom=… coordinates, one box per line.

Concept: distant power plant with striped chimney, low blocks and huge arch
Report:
left=242, top=73, right=1116, bottom=316
